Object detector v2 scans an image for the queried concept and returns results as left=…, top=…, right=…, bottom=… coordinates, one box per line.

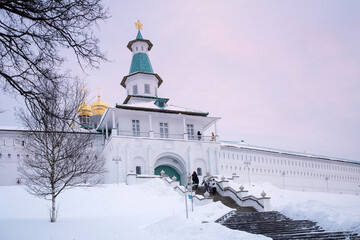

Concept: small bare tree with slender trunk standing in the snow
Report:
left=19, top=81, right=105, bottom=222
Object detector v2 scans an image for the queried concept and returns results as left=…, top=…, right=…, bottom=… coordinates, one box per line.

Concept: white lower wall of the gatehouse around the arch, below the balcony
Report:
left=104, top=135, right=220, bottom=186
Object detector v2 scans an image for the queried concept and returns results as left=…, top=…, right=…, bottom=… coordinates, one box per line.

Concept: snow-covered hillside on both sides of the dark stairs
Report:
left=0, top=179, right=360, bottom=240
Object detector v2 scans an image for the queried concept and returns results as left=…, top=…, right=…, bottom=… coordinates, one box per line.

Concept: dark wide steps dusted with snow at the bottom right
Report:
left=218, top=211, right=360, bottom=240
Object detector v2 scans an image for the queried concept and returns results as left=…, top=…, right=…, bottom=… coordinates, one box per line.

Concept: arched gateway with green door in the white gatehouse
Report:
left=154, top=153, right=187, bottom=185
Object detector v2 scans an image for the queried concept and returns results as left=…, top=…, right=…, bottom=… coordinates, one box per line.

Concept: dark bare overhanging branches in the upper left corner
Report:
left=0, top=0, right=108, bottom=110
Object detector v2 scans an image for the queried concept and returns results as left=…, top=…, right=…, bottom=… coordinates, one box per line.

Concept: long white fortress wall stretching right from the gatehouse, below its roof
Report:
left=219, top=147, right=360, bottom=193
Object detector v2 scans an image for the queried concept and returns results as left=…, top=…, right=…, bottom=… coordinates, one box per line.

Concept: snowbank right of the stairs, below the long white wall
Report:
left=229, top=181, right=360, bottom=233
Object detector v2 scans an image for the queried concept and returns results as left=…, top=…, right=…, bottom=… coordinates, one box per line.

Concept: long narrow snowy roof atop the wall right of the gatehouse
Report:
left=220, top=141, right=360, bottom=164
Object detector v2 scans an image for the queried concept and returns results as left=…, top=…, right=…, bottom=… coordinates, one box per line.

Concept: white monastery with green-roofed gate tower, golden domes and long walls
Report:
left=0, top=25, right=360, bottom=194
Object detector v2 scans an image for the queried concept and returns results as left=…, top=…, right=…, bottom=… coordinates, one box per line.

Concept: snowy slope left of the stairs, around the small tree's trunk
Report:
left=0, top=179, right=269, bottom=240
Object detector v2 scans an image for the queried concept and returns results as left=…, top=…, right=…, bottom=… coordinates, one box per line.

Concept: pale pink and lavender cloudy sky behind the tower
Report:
left=0, top=0, right=360, bottom=161
